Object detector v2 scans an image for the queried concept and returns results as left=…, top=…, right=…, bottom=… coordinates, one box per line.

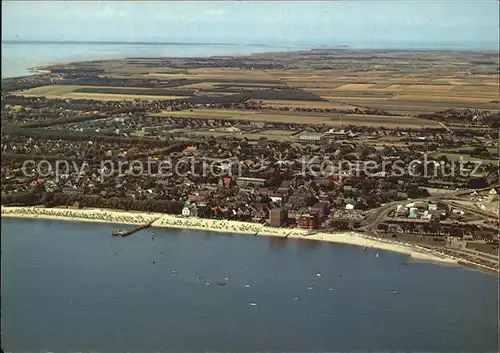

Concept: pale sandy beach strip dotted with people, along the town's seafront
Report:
left=1, top=207, right=458, bottom=264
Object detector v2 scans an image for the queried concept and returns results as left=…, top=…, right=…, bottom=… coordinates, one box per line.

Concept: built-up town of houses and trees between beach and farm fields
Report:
left=1, top=91, right=498, bottom=242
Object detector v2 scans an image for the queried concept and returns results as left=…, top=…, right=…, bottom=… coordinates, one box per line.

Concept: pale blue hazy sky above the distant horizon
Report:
left=2, top=0, right=499, bottom=46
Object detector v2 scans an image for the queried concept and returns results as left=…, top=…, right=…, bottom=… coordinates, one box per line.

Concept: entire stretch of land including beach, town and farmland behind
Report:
left=1, top=51, right=500, bottom=271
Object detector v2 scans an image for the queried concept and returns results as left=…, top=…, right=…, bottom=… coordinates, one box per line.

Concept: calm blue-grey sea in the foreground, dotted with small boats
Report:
left=1, top=219, right=498, bottom=352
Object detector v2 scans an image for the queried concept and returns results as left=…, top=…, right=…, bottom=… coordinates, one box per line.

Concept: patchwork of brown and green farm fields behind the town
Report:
left=8, top=50, right=499, bottom=122
